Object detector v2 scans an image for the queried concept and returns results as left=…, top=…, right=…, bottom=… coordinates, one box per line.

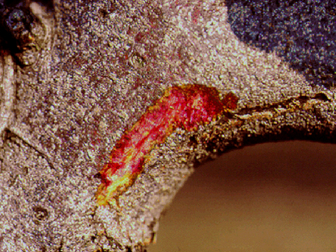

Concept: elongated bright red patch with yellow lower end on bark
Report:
left=96, top=84, right=238, bottom=205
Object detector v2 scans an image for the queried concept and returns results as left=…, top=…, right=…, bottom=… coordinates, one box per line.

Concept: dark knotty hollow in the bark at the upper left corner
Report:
left=0, top=0, right=54, bottom=66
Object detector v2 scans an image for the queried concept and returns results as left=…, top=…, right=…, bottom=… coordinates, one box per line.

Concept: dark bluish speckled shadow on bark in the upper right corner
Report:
left=226, top=0, right=336, bottom=89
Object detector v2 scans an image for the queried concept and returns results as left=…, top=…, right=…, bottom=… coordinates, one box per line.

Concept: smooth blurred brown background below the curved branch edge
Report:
left=148, top=141, right=336, bottom=252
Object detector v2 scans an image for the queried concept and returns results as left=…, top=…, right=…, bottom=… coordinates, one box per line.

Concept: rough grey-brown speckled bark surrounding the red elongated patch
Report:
left=0, top=0, right=336, bottom=251
